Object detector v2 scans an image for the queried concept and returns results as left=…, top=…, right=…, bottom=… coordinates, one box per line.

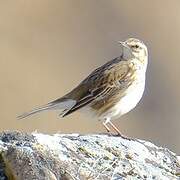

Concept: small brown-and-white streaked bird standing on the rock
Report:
left=17, top=38, right=148, bottom=136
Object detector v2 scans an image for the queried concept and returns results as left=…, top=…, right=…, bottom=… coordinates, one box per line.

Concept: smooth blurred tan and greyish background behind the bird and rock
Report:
left=0, top=0, right=180, bottom=154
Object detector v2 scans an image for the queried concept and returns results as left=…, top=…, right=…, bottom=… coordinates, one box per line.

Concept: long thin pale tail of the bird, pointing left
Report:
left=17, top=99, right=76, bottom=119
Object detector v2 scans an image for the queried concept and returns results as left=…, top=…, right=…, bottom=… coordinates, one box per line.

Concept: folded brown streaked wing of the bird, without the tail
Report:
left=61, top=59, right=130, bottom=117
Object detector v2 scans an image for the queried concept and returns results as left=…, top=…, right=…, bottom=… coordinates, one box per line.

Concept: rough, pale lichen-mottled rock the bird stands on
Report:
left=0, top=132, right=180, bottom=180
